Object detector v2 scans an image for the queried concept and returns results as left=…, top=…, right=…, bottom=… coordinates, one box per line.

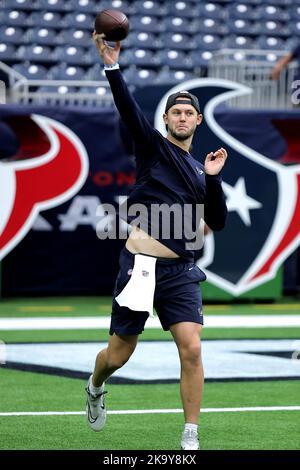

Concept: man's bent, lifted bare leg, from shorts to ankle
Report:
left=92, top=333, right=138, bottom=387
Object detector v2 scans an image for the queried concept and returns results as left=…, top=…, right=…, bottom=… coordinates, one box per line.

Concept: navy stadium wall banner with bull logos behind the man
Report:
left=0, top=79, right=300, bottom=300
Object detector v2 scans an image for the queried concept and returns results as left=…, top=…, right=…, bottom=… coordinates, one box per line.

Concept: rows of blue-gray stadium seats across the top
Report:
left=0, top=0, right=300, bottom=84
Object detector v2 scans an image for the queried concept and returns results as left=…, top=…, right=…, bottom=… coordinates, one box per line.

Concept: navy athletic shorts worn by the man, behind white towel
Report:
left=109, top=247, right=206, bottom=335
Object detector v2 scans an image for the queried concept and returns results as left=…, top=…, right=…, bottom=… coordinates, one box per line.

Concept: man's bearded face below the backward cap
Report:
left=164, top=100, right=202, bottom=141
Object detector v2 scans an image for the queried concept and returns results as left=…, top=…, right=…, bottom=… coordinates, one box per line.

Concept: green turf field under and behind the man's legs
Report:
left=0, top=298, right=300, bottom=450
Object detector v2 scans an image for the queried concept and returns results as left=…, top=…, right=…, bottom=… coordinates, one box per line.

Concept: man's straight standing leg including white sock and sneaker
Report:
left=170, top=322, right=204, bottom=450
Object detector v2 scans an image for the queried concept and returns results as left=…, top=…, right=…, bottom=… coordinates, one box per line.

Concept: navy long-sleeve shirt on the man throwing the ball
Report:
left=106, top=70, right=227, bottom=260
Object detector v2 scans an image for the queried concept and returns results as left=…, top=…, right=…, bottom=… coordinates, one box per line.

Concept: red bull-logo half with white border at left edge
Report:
left=0, top=115, right=88, bottom=259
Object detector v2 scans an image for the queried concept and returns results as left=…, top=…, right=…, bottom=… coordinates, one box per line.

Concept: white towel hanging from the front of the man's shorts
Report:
left=116, top=254, right=156, bottom=317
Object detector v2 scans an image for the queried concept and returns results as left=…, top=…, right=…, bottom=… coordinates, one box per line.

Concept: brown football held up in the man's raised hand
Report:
left=95, top=10, right=129, bottom=41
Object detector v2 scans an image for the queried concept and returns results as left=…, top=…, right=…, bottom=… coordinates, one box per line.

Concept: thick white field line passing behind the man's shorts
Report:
left=0, top=314, right=300, bottom=331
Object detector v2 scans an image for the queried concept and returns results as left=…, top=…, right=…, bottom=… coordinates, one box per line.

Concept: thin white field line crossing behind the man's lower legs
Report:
left=0, top=406, right=300, bottom=416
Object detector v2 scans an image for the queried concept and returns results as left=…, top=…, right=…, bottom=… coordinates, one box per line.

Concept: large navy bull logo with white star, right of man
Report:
left=155, top=78, right=300, bottom=295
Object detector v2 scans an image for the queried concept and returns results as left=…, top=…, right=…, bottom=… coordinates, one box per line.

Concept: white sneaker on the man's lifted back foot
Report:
left=85, top=376, right=107, bottom=431
